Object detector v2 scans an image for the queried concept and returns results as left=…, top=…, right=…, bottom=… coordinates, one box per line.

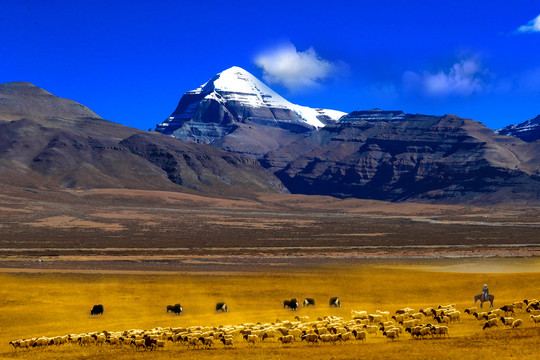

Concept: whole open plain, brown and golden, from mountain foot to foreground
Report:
left=0, top=189, right=540, bottom=359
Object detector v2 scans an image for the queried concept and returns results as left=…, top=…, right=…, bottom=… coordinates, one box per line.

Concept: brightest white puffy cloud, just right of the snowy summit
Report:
left=255, top=42, right=344, bottom=91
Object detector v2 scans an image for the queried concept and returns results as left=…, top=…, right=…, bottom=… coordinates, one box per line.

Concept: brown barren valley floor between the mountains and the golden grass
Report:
left=0, top=188, right=540, bottom=272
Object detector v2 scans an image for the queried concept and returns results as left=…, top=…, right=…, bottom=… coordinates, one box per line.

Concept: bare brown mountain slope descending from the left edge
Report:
left=0, top=83, right=284, bottom=196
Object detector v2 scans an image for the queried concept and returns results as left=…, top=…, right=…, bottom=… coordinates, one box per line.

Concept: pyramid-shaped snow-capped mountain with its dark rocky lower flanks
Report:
left=156, top=66, right=346, bottom=155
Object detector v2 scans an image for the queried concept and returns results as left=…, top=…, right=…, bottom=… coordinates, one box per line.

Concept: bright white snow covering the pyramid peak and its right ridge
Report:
left=190, top=66, right=346, bottom=128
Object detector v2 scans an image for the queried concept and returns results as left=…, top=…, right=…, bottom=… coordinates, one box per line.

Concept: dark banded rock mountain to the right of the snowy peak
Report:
left=261, top=109, right=540, bottom=202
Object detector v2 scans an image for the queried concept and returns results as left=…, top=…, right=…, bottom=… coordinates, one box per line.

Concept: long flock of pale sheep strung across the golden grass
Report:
left=10, top=300, right=540, bottom=350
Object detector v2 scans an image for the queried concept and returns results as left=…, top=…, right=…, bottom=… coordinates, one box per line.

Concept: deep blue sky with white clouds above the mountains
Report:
left=0, top=0, right=540, bottom=130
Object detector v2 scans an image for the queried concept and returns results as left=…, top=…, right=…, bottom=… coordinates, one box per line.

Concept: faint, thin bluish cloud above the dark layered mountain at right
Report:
left=403, top=59, right=485, bottom=97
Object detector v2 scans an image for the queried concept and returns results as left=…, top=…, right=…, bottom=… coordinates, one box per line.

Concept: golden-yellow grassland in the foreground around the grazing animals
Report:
left=0, top=260, right=540, bottom=360
